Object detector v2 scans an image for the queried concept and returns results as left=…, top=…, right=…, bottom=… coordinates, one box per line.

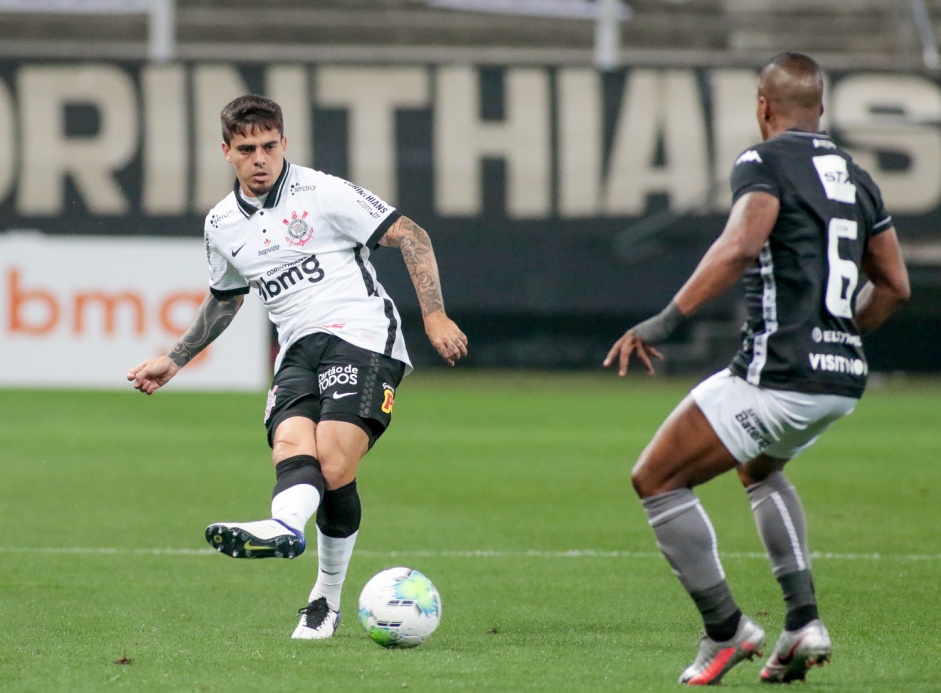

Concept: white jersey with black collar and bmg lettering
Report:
left=205, top=161, right=411, bottom=371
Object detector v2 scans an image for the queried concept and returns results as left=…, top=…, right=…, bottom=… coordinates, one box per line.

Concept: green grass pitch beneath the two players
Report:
left=0, top=368, right=941, bottom=693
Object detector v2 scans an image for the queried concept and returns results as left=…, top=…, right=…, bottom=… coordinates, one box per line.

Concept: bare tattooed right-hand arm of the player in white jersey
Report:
left=379, top=216, right=467, bottom=366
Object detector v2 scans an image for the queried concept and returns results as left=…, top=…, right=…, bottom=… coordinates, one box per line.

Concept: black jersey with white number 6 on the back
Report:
left=729, top=130, right=892, bottom=397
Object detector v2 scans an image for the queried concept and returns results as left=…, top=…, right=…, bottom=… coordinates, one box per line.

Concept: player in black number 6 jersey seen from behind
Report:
left=604, top=53, right=910, bottom=685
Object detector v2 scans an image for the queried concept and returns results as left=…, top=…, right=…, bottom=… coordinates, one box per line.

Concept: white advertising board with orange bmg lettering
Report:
left=0, top=233, right=270, bottom=391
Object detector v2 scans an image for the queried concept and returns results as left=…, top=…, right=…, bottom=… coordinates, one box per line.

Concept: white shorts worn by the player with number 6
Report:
left=690, top=368, right=859, bottom=463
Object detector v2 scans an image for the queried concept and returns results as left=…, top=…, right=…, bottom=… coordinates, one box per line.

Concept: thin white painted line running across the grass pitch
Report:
left=0, top=546, right=941, bottom=561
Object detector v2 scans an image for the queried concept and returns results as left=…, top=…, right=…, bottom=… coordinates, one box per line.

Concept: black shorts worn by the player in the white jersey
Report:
left=265, top=332, right=405, bottom=447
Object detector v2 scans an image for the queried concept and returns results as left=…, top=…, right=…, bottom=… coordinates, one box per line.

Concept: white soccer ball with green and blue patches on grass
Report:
left=359, top=567, right=441, bottom=647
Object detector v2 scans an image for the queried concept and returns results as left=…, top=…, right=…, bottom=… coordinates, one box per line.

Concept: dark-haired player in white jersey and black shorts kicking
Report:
left=127, top=95, right=467, bottom=640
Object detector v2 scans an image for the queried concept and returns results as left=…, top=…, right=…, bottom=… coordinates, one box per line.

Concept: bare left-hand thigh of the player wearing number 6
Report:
left=631, top=396, right=737, bottom=498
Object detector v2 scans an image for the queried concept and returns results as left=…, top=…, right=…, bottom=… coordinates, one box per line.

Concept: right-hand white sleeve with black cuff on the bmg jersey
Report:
left=321, top=176, right=401, bottom=248
